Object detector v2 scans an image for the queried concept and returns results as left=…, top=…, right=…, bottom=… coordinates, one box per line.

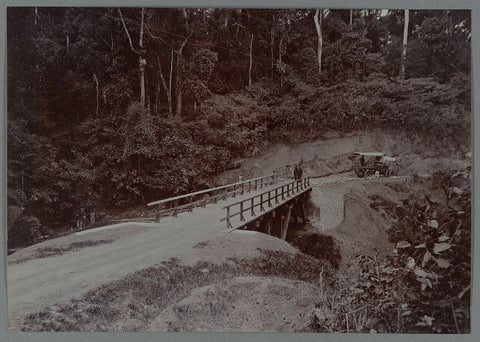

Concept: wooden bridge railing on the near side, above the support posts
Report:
left=220, top=177, right=310, bottom=228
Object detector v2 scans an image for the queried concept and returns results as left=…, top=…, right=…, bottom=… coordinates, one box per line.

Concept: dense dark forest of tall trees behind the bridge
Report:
left=7, top=7, right=471, bottom=244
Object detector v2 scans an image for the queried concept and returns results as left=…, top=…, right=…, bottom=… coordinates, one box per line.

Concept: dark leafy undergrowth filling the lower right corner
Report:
left=312, top=170, right=471, bottom=333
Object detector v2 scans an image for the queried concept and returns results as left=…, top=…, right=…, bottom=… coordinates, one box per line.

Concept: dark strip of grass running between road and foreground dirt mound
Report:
left=22, top=250, right=334, bottom=331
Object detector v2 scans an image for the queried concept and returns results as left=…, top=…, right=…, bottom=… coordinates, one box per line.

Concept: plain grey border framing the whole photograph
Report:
left=0, top=0, right=480, bottom=342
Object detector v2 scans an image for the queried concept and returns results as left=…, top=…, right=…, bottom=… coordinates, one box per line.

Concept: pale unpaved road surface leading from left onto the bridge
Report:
left=7, top=183, right=284, bottom=330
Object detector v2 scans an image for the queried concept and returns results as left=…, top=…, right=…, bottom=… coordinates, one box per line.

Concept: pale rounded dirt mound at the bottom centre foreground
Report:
left=148, top=277, right=321, bottom=332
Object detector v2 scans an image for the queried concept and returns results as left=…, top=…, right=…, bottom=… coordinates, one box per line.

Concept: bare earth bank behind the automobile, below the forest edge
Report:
left=219, top=130, right=465, bottom=181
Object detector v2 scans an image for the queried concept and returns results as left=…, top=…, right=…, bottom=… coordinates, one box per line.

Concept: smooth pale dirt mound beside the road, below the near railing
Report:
left=182, top=230, right=298, bottom=265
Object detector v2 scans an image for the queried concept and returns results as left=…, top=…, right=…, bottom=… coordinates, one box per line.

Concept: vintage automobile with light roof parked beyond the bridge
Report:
left=353, top=152, right=400, bottom=177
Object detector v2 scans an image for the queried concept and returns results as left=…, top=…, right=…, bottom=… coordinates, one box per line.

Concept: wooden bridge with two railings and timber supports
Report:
left=147, top=172, right=312, bottom=240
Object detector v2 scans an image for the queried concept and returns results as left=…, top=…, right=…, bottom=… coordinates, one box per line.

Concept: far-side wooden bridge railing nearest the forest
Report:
left=147, top=172, right=277, bottom=221
